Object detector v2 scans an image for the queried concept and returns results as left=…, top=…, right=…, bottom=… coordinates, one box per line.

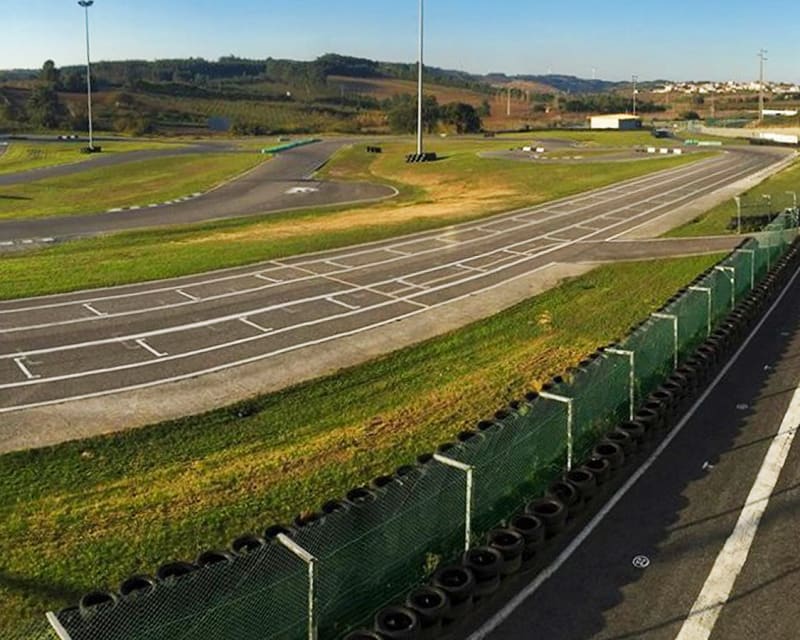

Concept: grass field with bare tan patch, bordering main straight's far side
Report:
left=0, top=141, right=707, bottom=298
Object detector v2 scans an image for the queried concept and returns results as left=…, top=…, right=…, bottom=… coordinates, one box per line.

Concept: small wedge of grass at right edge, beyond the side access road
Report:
left=666, top=155, right=800, bottom=238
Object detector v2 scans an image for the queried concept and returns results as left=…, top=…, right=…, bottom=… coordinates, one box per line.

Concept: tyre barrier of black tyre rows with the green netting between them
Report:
left=56, top=216, right=800, bottom=640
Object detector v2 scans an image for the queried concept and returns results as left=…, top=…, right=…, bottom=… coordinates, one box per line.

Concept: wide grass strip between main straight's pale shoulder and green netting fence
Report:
left=0, top=251, right=719, bottom=637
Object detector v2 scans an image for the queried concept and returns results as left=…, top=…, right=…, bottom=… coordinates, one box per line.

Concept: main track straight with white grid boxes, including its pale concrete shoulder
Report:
left=0, top=144, right=793, bottom=450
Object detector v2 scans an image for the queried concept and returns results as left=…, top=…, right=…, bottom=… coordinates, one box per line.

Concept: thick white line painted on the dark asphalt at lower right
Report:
left=675, top=396, right=800, bottom=640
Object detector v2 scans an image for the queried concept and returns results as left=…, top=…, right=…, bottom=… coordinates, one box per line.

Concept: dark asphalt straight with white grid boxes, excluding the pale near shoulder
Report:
left=0, top=146, right=785, bottom=413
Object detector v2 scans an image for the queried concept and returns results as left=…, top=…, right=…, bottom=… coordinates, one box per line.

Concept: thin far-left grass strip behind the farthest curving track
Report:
left=0, top=140, right=188, bottom=175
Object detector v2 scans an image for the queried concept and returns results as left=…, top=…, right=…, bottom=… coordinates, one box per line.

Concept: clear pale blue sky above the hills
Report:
left=0, top=0, right=800, bottom=82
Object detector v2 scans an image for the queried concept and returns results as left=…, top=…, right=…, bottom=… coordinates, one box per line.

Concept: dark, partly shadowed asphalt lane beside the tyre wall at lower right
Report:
left=472, top=258, right=800, bottom=640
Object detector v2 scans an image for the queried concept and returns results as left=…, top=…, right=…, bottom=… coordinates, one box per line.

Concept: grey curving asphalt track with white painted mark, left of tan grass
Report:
left=0, top=140, right=397, bottom=246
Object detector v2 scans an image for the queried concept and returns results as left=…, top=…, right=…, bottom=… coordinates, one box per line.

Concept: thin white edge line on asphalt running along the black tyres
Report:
left=468, top=262, right=800, bottom=640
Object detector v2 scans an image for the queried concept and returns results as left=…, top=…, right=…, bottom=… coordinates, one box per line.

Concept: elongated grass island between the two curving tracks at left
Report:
left=0, top=153, right=264, bottom=219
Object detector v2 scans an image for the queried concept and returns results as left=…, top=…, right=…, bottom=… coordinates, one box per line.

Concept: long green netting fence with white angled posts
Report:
left=28, top=210, right=797, bottom=640
